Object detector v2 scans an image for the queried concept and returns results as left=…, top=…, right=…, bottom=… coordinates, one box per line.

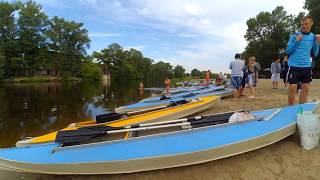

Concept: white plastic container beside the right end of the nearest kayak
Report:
left=297, top=111, right=320, bottom=150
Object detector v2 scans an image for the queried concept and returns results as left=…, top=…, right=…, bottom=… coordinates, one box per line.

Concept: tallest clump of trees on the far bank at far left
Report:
left=0, top=1, right=99, bottom=78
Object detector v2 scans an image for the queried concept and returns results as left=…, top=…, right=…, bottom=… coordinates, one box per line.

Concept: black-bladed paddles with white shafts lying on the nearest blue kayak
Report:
left=55, top=112, right=242, bottom=144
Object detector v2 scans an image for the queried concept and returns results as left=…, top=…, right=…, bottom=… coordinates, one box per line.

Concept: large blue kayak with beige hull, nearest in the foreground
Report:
left=0, top=103, right=319, bottom=174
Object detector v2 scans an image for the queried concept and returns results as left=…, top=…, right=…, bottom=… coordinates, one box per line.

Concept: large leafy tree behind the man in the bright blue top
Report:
left=242, top=0, right=320, bottom=77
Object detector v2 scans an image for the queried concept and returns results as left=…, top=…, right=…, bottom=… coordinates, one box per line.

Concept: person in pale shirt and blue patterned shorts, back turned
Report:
left=229, top=53, right=244, bottom=98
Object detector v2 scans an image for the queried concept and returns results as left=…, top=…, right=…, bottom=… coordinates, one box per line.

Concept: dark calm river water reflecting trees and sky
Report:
left=0, top=82, right=150, bottom=147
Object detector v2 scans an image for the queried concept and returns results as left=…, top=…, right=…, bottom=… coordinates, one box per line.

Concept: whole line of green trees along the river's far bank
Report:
left=0, top=1, right=190, bottom=80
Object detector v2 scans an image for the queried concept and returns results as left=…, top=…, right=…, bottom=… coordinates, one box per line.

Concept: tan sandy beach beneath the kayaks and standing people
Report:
left=0, top=80, right=320, bottom=180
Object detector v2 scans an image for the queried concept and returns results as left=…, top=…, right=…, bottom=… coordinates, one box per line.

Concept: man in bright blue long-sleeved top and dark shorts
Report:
left=286, top=16, right=320, bottom=105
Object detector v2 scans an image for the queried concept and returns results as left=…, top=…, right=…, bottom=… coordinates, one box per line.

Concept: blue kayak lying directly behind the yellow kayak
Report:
left=115, top=88, right=233, bottom=113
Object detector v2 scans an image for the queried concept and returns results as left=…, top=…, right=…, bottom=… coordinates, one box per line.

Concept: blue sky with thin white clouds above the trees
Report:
left=16, top=0, right=304, bottom=73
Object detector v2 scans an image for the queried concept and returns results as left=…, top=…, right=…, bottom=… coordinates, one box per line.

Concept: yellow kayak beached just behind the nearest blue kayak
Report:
left=16, top=96, right=220, bottom=146
